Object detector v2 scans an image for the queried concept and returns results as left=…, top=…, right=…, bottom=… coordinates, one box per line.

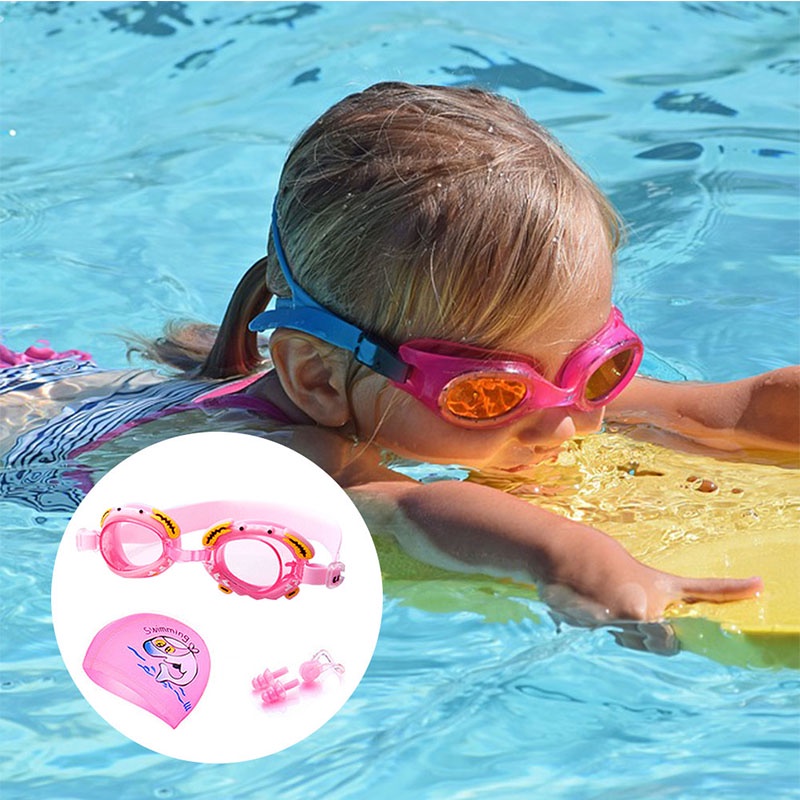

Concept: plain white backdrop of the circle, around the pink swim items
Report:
left=52, top=432, right=382, bottom=763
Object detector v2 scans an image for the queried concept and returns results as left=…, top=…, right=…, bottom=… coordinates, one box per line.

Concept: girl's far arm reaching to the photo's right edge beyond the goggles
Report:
left=606, top=367, right=800, bottom=451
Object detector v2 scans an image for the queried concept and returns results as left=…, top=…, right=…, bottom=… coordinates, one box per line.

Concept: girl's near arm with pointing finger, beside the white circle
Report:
left=349, top=481, right=762, bottom=623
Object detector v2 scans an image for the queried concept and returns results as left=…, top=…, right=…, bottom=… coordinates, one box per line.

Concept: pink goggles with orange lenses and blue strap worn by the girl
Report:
left=249, top=203, right=643, bottom=427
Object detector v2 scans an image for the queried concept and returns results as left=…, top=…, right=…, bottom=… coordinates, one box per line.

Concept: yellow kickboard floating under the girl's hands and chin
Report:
left=512, top=433, right=800, bottom=669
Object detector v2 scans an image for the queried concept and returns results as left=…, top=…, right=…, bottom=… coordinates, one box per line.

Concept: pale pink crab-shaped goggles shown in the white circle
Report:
left=77, top=502, right=344, bottom=600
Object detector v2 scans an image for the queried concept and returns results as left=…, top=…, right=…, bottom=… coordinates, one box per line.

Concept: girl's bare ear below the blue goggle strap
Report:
left=269, top=329, right=350, bottom=428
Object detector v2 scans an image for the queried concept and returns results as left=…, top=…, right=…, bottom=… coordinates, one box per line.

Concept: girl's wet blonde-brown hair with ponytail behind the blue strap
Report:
left=136, top=83, right=620, bottom=377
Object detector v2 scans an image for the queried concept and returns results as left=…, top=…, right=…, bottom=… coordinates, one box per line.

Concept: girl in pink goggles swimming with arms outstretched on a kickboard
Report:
left=0, top=84, right=800, bottom=621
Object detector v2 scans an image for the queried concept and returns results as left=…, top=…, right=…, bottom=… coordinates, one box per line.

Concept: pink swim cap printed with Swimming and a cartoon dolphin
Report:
left=83, top=614, right=211, bottom=728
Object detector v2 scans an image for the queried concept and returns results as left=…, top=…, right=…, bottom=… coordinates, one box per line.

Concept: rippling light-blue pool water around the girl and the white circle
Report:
left=0, top=3, right=800, bottom=800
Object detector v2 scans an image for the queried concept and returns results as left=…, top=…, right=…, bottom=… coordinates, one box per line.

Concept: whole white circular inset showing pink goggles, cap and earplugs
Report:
left=52, top=432, right=383, bottom=763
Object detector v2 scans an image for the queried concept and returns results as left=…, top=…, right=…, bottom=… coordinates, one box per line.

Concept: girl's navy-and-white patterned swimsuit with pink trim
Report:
left=0, top=354, right=290, bottom=512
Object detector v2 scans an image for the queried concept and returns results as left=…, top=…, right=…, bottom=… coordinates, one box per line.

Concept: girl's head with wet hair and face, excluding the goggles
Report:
left=205, top=83, right=632, bottom=469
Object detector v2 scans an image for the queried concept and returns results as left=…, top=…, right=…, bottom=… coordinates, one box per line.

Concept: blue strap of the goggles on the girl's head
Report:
left=247, top=206, right=411, bottom=383
